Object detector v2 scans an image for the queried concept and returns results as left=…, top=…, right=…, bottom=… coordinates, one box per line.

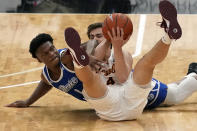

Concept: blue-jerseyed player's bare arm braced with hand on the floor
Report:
left=6, top=74, right=52, bottom=108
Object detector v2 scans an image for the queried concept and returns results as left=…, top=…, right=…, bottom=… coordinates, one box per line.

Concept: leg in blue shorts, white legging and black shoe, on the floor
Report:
left=146, top=63, right=197, bottom=109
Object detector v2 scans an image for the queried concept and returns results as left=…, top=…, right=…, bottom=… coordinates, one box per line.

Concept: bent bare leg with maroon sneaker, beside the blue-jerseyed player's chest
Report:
left=65, top=28, right=107, bottom=98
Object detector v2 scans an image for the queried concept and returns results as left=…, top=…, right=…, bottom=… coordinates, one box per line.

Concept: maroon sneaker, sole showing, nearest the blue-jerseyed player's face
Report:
left=64, top=27, right=89, bottom=68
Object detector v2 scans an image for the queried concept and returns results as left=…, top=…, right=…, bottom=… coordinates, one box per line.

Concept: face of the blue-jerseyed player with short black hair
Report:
left=36, top=41, right=60, bottom=66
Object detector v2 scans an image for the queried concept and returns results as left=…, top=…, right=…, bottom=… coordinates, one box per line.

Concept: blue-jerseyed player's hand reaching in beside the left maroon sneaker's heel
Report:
left=89, top=55, right=103, bottom=72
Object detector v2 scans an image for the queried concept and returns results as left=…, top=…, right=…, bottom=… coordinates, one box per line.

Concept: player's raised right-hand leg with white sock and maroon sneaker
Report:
left=133, top=1, right=182, bottom=85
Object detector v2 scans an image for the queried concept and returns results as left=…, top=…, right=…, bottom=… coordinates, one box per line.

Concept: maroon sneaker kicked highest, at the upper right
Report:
left=159, top=0, right=182, bottom=39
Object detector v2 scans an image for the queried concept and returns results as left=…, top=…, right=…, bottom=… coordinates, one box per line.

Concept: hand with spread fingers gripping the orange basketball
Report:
left=108, top=27, right=130, bottom=48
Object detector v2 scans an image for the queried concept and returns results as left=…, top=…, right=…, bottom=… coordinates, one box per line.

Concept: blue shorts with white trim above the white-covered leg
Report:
left=145, top=78, right=168, bottom=109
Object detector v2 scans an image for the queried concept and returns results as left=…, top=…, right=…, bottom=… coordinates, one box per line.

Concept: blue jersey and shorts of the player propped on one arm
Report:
left=43, top=48, right=167, bottom=109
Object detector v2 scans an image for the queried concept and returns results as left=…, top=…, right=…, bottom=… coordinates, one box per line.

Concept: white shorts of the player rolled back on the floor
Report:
left=83, top=73, right=152, bottom=121
